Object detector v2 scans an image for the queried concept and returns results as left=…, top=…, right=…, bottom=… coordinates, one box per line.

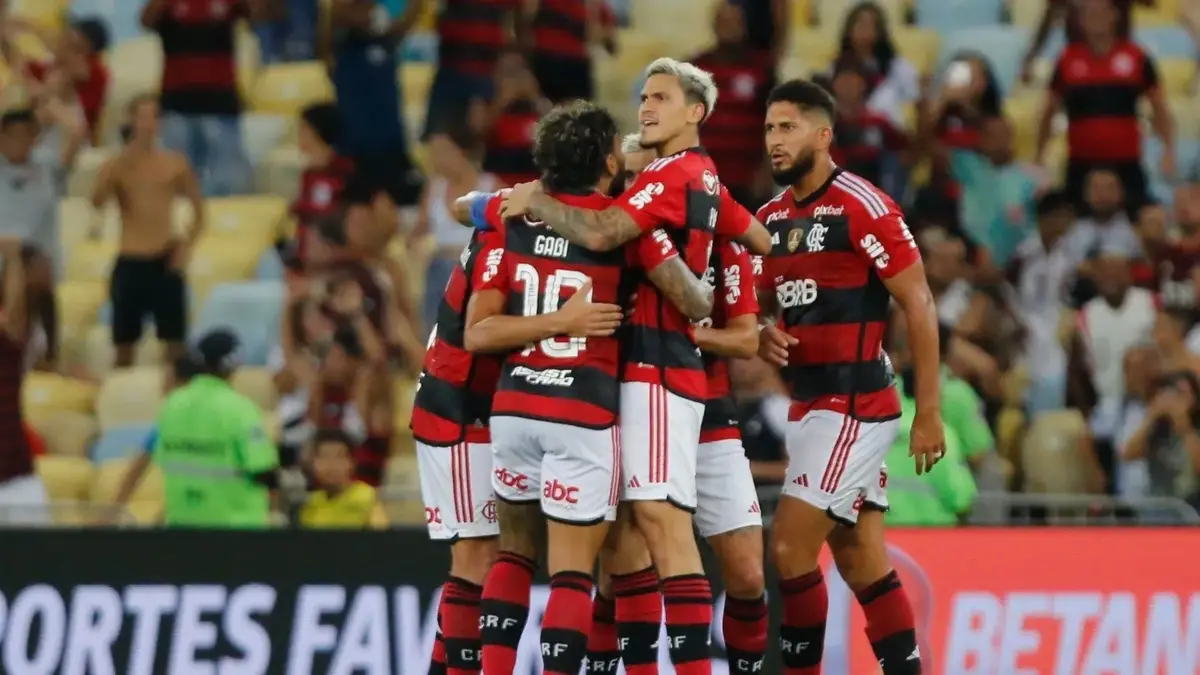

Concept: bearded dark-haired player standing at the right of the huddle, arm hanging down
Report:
left=758, top=80, right=944, bottom=675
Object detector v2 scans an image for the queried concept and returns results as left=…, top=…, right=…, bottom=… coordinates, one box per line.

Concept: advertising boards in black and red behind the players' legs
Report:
left=0, top=528, right=1200, bottom=675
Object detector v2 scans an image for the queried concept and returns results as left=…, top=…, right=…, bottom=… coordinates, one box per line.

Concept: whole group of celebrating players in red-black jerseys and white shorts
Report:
left=413, top=59, right=943, bottom=675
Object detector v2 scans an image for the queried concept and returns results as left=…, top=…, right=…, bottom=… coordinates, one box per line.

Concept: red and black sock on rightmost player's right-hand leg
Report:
left=857, top=571, right=920, bottom=675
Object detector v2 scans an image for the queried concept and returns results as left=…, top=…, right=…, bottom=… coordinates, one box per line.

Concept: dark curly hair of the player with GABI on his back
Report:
left=533, top=101, right=618, bottom=193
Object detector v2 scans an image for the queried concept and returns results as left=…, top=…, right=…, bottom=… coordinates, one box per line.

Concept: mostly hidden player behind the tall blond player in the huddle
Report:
left=588, top=133, right=767, bottom=674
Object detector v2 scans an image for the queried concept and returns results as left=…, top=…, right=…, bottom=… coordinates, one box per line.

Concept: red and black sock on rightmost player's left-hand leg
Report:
left=779, top=569, right=829, bottom=675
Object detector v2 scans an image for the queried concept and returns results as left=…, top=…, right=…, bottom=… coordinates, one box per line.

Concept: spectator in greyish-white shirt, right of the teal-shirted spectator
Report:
left=1008, top=191, right=1075, bottom=410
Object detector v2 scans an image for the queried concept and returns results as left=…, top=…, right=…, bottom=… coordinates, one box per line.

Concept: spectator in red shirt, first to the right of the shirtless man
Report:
left=280, top=103, right=354, bottom=271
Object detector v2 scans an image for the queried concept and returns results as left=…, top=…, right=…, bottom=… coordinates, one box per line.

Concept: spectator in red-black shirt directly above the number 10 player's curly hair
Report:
left=469, top=48, right=550, bottom=185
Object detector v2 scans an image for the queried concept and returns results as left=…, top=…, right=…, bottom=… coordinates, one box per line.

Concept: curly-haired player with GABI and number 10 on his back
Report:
left=467, top=102, right=713, bottom=675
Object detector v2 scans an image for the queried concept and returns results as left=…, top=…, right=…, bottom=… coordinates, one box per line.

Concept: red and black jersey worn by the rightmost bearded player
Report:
left=758, top=169, right=920, bottom=420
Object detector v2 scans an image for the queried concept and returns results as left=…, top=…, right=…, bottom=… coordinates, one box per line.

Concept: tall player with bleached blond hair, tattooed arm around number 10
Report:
left=502, top=59, right=769, bottom=675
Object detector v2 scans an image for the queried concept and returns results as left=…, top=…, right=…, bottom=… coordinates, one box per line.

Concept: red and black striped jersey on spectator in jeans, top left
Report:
left=154, top=0, right=250, bottom=115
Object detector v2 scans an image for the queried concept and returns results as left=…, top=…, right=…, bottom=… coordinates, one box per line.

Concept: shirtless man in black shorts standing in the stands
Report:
left=91, top=96, right=204, bottom=368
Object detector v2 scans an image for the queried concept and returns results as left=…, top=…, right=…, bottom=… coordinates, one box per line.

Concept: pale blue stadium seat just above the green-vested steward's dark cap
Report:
left=192, top=281, right=284, bottom=365
